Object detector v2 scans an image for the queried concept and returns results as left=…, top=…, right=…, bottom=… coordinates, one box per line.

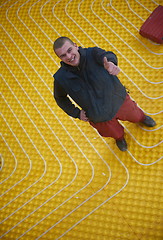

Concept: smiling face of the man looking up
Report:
left=55, top=41, right=80, bottom=66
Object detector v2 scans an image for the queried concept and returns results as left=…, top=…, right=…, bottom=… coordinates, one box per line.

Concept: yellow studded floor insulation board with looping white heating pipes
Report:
left=0, top=0, right=163, bottom=240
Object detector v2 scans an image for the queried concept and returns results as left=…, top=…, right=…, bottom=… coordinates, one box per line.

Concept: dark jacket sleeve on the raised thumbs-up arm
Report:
left=92, top=47, right=118, bottom=65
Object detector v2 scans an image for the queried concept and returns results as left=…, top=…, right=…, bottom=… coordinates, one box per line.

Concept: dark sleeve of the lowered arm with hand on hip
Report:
left=54, top=80, right=80, bottom=119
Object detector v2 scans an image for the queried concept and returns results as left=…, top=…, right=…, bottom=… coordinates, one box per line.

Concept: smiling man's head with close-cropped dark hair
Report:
left=53, top=37, right=80, bottom=66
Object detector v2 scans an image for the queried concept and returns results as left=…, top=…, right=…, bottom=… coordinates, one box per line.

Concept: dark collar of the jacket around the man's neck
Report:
left=60, top=47, right=86, bottom=72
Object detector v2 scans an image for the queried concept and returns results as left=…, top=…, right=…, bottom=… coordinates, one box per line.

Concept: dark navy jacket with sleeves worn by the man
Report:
left=53, top=47, right=126, bottom=123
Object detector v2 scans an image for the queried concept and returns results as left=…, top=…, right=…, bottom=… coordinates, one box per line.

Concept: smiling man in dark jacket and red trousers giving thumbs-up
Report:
left=53, top=37, right=156, bottom=151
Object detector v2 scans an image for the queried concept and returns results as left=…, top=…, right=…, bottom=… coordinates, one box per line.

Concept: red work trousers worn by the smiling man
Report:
left=90, top=95, right=145, bottom=140
